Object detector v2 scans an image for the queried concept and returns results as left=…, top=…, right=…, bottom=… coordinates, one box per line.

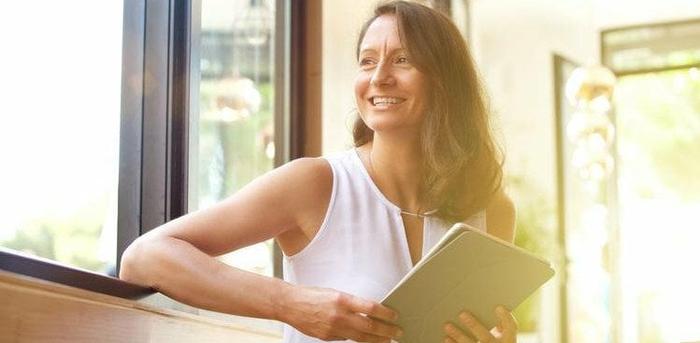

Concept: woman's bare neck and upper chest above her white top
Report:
left=363, top=134, right=429, bottom=213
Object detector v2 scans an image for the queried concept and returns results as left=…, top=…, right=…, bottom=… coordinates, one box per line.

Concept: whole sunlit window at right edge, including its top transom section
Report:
left=602, top=19, right=700, bottom=342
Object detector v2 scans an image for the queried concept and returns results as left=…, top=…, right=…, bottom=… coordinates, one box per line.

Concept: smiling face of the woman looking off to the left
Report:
left=355, top=15, right=427, bottom=136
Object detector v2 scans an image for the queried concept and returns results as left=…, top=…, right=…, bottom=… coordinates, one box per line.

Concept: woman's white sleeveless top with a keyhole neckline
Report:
left=283, top=149, right=486, bottom=343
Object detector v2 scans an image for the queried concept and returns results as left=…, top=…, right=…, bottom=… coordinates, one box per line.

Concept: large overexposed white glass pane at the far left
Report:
left=0, top=0, right=123, bottom=273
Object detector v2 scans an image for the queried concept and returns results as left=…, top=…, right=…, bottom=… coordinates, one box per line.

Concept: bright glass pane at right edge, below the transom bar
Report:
left=615, top=69, right=700, bottom=343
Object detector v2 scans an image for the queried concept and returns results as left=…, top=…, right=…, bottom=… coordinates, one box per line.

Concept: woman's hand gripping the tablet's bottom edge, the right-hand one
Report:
left=443, top=306, right=518, bottom=343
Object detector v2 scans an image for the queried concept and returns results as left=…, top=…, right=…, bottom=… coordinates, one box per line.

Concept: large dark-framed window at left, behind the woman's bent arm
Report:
left=0, top=0, right=308, bottom=318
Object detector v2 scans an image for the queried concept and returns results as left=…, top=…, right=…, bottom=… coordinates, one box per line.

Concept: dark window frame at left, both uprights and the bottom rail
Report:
left=0, top=0, right=306, bottom=299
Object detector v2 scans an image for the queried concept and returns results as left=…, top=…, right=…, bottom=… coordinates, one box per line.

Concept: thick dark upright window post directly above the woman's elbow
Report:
left=117, top=0, right=194, bottom=270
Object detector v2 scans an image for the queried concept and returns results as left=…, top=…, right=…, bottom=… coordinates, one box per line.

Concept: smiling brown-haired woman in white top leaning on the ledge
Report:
left=121, top=1, right=517, bottom=342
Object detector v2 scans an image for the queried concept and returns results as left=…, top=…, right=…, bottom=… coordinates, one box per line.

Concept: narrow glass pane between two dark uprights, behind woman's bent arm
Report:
left=196, top=0, right=274, bottom=275
